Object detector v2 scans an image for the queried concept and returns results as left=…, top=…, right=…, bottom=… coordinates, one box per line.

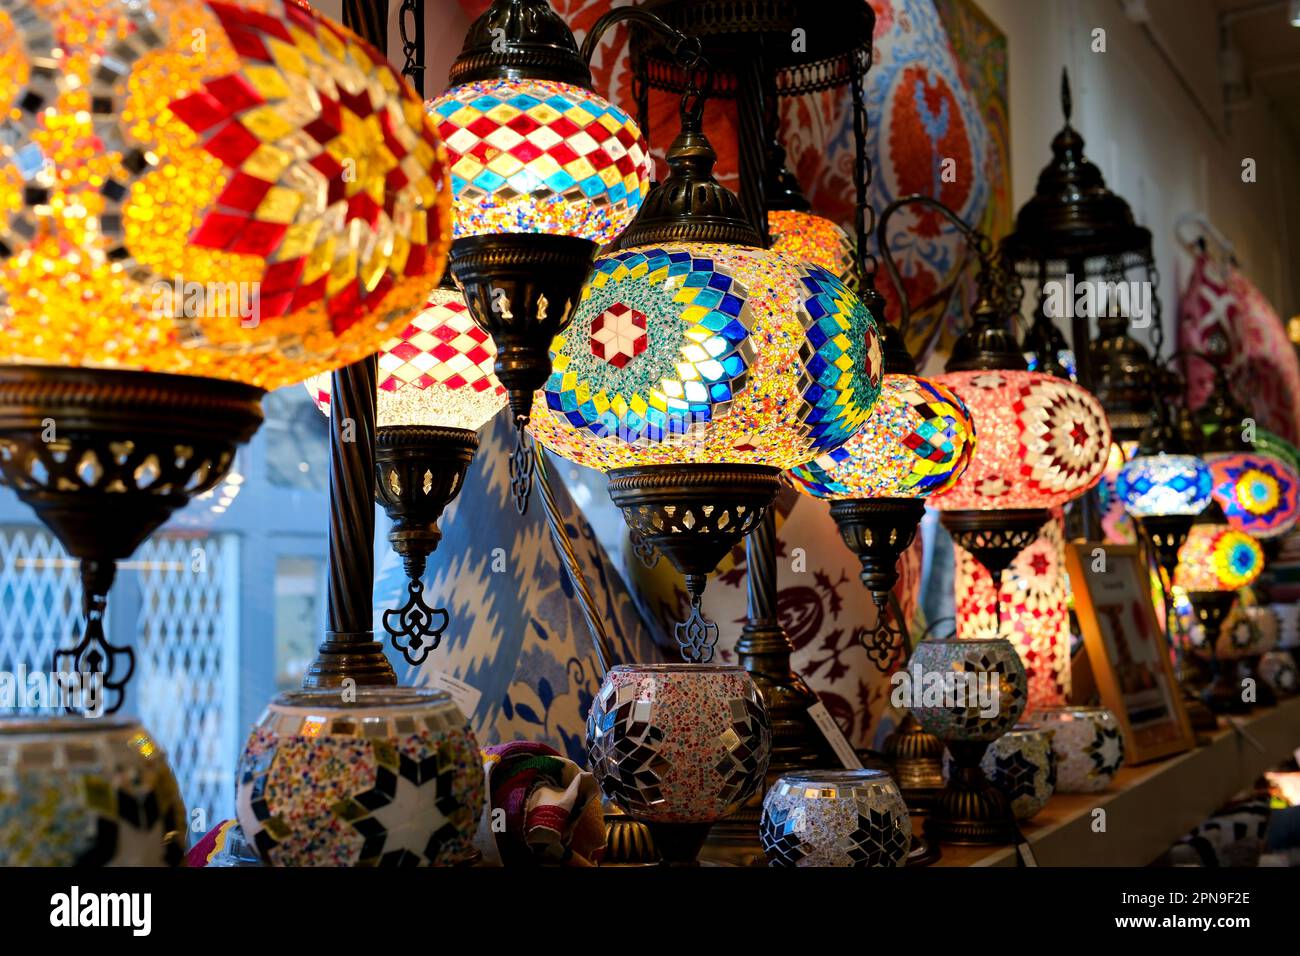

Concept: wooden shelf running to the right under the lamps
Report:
left=913, top=697, right=1300, bottom=866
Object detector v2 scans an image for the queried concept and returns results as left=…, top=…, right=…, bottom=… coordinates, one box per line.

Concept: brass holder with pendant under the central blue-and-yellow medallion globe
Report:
left=608, top=464, right=780, bottom=663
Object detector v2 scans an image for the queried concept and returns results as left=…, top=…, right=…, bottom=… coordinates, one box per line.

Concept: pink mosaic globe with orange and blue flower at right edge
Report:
left=1205, top=451, right=1300, bottom=537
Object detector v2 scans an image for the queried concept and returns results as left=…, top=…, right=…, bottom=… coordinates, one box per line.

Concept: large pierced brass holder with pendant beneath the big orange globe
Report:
left=0, top=365, right=264, bottom=713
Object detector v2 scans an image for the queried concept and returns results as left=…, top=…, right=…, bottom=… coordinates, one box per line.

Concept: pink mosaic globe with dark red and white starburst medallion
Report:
left=931, top=369, right=1110, bottom=511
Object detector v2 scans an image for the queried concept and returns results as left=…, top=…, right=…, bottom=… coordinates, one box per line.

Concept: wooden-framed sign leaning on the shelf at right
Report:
left=1066, top=541, right=1196, bottom=763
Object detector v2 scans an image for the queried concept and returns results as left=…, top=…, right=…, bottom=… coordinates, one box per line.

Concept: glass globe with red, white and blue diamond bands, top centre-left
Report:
left=429, top=79, right=654, bottom=243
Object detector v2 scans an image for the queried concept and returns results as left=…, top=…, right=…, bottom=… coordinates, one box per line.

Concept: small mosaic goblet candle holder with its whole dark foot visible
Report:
left=907, top=637, right=1028, bottom=844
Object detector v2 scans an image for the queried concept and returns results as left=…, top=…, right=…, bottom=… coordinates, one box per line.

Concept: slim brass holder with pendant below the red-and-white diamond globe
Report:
left=374, top=425, right=478, bottom=667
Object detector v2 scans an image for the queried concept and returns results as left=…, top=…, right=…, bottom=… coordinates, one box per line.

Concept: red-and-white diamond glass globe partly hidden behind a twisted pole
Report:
left=304, top=289, right=506, bottom=431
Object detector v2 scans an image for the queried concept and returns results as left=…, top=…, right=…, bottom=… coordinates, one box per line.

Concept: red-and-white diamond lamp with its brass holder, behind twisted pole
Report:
left=304, top=278, right=507, bottom=667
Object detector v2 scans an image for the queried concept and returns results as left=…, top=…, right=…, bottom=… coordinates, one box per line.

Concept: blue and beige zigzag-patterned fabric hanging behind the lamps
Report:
left=374, top=415, right=659, bottom=766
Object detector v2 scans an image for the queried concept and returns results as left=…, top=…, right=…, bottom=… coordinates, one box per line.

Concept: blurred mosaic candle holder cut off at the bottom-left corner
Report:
left=0, top=717, right=189, bottom=866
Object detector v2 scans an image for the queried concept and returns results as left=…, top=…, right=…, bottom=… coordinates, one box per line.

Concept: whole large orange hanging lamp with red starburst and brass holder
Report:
left=0, top=0, right=450, bottom=708
